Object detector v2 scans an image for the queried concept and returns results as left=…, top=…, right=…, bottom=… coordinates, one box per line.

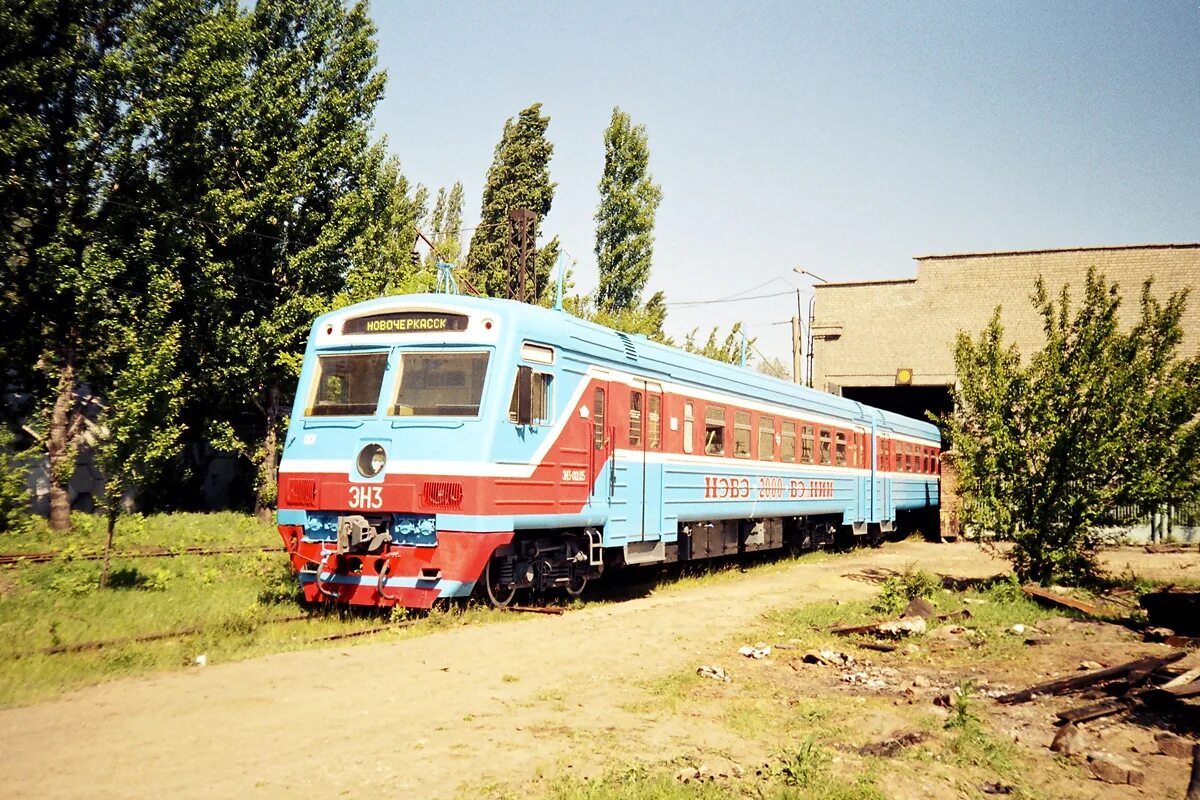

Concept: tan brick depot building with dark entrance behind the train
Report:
left=812, top=243, right=1200, bottom=416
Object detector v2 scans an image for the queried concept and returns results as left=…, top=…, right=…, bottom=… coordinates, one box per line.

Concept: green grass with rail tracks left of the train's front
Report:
left=0, top=513, right=520, bottom=706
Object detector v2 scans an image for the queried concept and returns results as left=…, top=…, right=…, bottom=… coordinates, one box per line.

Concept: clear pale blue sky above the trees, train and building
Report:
left=372, top=0, right=1200, bottom=365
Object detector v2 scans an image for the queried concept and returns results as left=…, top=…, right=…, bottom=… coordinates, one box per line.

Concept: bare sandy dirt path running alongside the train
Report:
left=0, top=541, right=1200, bottom=800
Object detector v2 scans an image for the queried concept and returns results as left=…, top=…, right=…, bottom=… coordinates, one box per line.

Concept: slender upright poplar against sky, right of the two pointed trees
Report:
left=595, top=108, right=662, bottom=312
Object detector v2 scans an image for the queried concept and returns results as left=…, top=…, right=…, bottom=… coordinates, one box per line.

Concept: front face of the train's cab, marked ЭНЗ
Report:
left=277, top=295, right=515, bottom=608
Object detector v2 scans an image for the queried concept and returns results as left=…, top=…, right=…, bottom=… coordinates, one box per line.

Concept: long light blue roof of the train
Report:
left=314, top=294, right=940, bottom=439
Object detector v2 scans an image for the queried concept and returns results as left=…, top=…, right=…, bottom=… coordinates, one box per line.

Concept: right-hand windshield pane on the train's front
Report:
left=391, top=353, right=487, bottom=416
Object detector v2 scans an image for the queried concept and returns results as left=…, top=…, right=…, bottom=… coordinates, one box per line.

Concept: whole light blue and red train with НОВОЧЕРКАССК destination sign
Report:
left=278, top=294, right=940, bottom=608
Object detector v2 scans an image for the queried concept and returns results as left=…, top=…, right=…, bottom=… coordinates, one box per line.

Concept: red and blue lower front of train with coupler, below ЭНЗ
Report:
left=278, top=510, right=512, bottom=608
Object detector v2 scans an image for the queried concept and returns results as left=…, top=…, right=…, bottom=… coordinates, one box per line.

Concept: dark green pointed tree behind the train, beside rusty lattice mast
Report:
left=467, top=103, right=559, bottom=300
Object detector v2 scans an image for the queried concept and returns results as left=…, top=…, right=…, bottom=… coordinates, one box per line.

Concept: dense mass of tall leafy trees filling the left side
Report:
left=0, top=0, right=403, bottom=528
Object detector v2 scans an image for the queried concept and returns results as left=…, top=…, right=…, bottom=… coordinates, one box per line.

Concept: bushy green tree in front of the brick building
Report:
left=942, top=270, right=1200, bottom=583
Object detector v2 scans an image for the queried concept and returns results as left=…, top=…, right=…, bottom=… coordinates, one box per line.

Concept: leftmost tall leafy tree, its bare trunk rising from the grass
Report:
left=0, top=0, right=146, bottom=530
